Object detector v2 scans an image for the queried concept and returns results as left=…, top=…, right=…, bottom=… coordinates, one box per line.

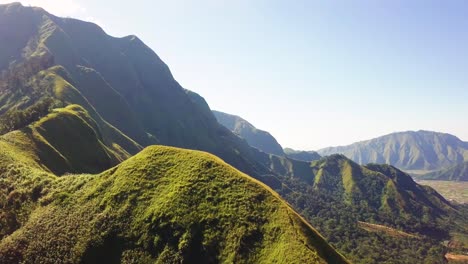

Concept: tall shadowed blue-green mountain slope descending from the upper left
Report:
left=0, top=4, right=308, bottom=184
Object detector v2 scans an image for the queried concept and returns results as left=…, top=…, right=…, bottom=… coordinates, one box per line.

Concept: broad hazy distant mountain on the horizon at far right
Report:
left=318, top=130, right=468, bottom=171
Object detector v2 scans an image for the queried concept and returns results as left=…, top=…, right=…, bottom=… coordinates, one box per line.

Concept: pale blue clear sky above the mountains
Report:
left=0, top=0, right=468, bottom=150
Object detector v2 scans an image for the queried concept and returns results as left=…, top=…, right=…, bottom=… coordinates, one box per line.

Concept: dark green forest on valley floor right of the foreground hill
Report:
left=286, top=182, right=447, bottom=263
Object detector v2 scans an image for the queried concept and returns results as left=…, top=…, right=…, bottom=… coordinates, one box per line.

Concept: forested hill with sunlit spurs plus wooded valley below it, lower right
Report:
left=280, top=156, right=468, bottom=263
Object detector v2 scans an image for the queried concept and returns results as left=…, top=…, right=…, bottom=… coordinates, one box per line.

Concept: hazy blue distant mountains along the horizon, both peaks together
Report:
left=213, top=111, right=468, bottom=181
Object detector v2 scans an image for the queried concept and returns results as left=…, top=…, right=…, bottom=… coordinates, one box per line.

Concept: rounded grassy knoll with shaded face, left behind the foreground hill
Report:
left=0, top=105, right=138, bottom=175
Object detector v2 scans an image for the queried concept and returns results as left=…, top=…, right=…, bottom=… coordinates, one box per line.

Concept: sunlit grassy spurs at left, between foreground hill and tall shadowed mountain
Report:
left=3, top=66, right=142, bottom=171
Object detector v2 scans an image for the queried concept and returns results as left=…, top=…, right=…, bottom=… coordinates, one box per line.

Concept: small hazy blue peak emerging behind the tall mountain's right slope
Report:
left=213, top=110, right=284, bottom=156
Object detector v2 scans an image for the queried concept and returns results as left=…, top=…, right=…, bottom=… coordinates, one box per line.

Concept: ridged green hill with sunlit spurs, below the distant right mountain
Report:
left=304, top=155, right=452, bottom=221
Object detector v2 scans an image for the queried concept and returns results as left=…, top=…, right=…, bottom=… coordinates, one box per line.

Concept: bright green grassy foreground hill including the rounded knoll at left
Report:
left=0, top=109, right=347, bottom=263
